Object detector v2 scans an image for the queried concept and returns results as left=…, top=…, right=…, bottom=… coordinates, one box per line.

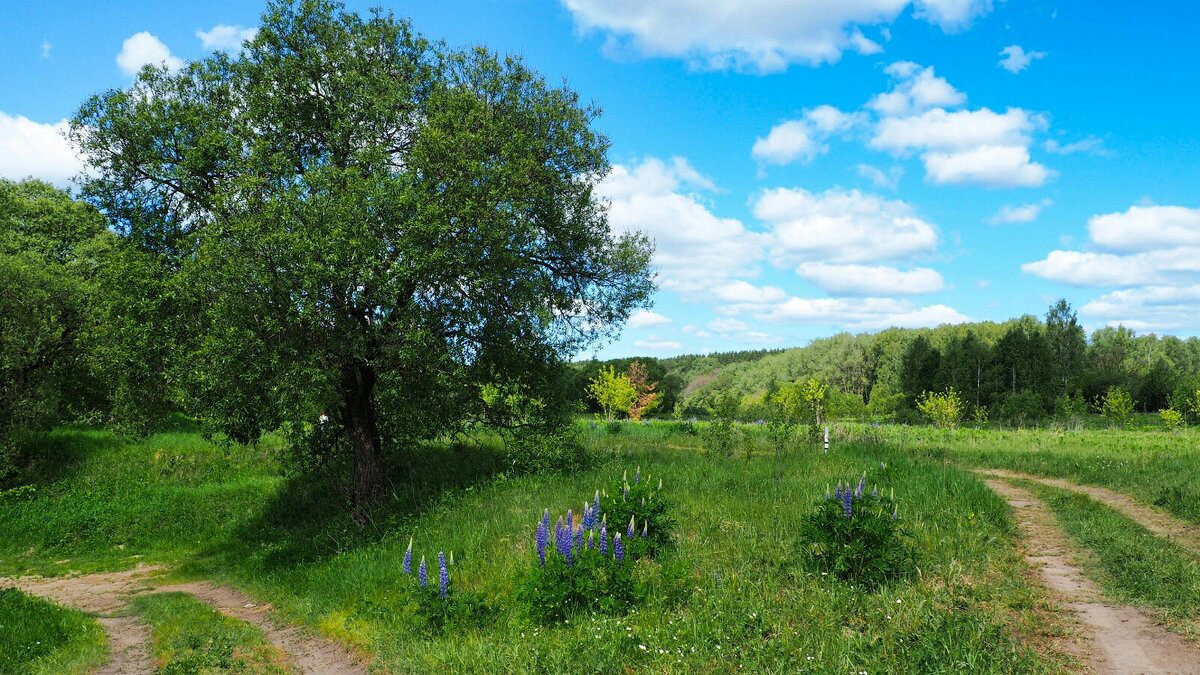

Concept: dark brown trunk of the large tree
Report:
left=342, top=363, right=383, bottom=527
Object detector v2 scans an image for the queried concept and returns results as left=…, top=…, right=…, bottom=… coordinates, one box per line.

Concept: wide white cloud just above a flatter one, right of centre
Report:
left=754, top=187, right=937, bottom=267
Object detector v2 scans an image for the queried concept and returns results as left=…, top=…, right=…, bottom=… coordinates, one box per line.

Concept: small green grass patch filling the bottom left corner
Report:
left=0, top=589, right=104, bottom=675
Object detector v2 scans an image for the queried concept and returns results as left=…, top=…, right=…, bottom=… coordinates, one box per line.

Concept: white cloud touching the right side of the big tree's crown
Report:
left=596, top=159, right=763, bottom=293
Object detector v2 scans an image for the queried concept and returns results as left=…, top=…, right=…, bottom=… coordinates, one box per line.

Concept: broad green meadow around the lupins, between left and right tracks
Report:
left=0, top=423, right=1066, bottom=673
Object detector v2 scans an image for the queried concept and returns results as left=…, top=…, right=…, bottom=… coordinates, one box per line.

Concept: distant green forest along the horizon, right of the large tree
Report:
left=572, top=300, right=1200, bottom=423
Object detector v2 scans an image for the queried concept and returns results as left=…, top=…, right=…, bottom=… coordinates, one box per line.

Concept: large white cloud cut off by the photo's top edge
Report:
left=562, top=0, right=991, bottom=73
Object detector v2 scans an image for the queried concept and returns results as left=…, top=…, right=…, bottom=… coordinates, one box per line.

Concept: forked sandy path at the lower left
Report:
left=0, top=565, right=367, bottom=675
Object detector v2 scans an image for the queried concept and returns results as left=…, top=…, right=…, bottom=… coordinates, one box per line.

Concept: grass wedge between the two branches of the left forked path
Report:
left=132, top=593, right=293, bottom=675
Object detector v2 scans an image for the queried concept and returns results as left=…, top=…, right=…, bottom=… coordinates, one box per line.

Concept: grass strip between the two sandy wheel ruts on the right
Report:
left=1018, top=480, right=1200, bottom=638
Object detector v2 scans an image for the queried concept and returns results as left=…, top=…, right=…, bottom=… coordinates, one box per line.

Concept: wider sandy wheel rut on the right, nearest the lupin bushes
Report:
left=986, top=479, right=1200, bottom=675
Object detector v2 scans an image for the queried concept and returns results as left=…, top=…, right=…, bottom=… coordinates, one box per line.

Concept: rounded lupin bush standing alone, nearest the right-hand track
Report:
left=800, top=473, right=913, bottom=589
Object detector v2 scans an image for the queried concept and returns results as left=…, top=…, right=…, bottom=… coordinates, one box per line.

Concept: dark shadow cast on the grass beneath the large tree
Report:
left=196, top=444, right=504, bottom=573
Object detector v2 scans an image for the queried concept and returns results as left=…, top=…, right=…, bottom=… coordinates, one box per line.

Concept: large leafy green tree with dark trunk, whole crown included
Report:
left=72, top=0, right=653, bottom=519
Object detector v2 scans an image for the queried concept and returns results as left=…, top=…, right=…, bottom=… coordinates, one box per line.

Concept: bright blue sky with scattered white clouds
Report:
left=0, top=0, right=1200, bottom=357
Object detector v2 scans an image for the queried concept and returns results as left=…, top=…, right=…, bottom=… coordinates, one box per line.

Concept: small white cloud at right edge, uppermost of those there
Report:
left=1087, top=207, right=1200, bottom=251
